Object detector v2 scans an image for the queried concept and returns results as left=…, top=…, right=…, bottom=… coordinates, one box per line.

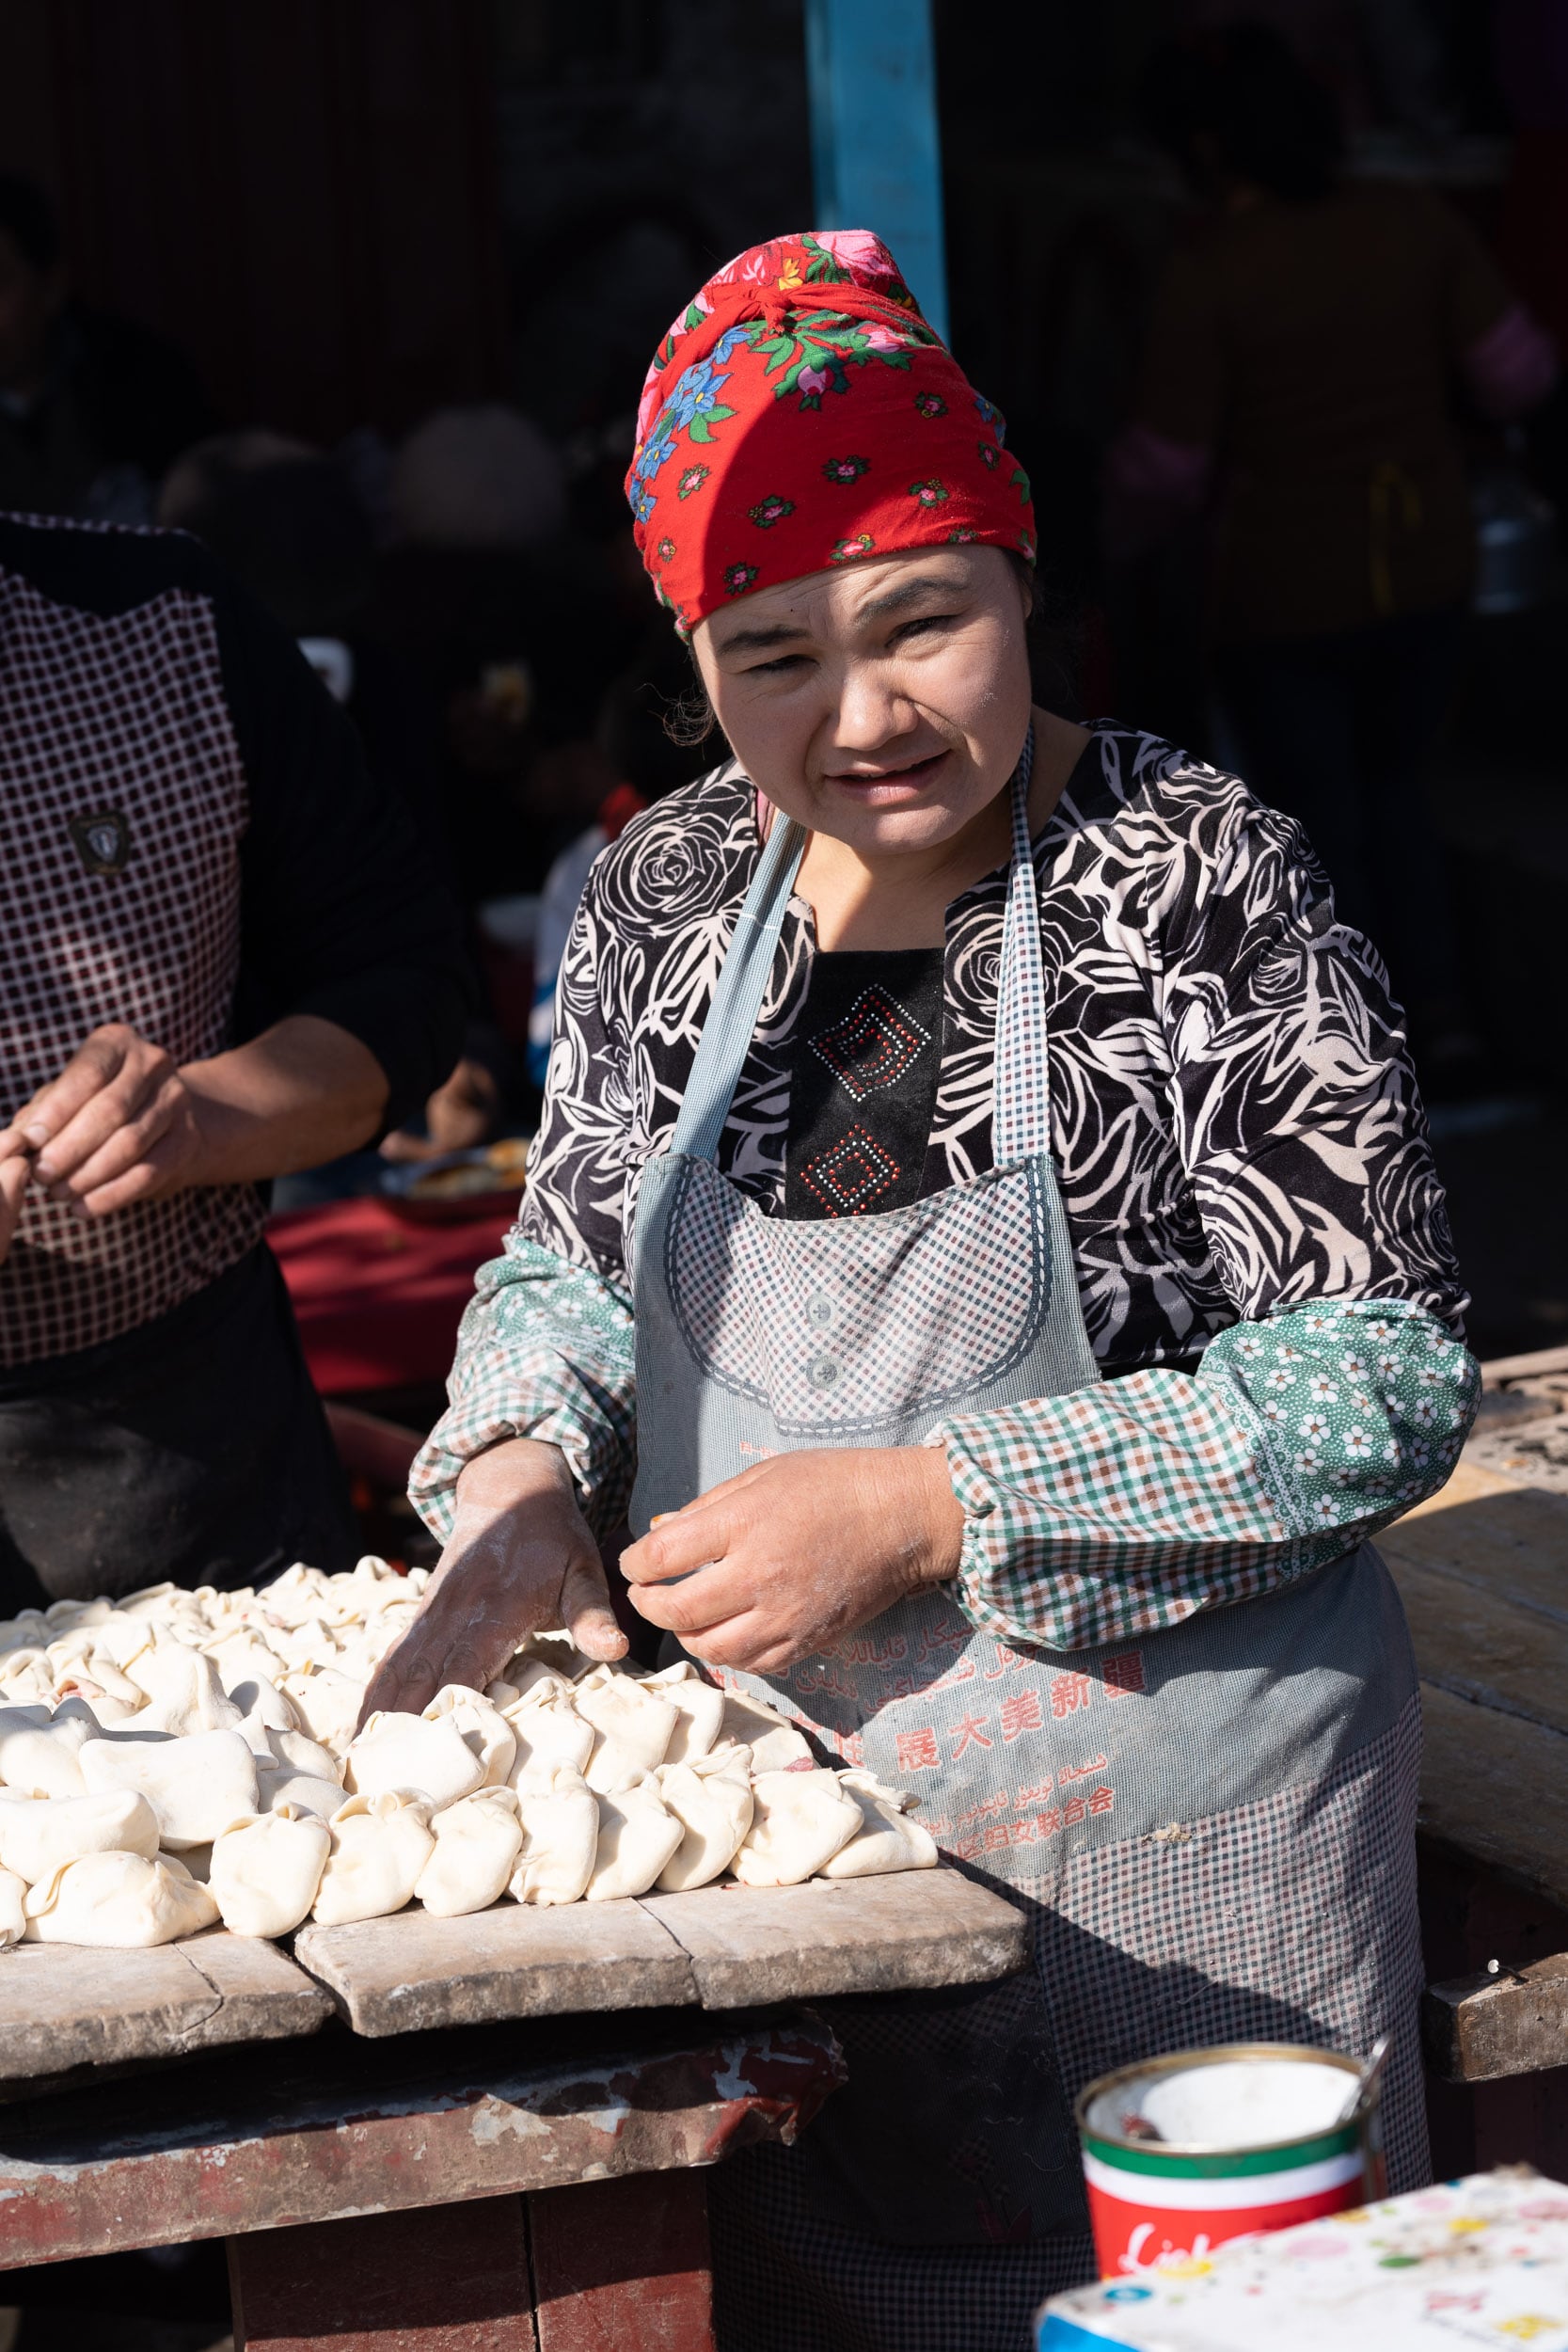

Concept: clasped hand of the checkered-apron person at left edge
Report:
left=0, top=1021, right=207, bottom=1232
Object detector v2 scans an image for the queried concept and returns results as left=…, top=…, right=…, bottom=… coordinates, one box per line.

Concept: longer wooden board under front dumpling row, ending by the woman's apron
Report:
left=293, top=1870, right=1025, bottom=2035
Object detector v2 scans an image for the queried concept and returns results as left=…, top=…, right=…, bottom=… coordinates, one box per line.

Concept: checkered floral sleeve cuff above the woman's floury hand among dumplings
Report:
left=409, top=1228, right=637, bottom=1543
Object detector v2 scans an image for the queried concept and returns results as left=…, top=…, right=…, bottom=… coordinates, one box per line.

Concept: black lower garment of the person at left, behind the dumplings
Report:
left=0, top=1245, right=357, bottom=1616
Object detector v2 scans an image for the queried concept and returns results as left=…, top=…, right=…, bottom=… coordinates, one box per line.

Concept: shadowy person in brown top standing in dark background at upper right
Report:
left=1110, top=24, right=1557, bottom=1085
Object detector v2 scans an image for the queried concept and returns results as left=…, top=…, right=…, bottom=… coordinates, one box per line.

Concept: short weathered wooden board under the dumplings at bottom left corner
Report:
left=0, top=1929, right=331, bottom=2084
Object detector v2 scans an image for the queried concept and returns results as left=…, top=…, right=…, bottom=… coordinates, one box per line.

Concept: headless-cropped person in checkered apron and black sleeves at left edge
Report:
left=0, top=516, right=466, bottom=1616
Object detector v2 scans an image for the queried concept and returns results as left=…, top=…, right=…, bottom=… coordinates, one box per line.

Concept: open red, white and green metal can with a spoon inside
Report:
left=1077, top=2042, right=1385, bottom=2280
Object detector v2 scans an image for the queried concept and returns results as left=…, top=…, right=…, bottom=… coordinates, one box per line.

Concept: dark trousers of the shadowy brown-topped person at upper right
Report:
left=1215, top=610, right=1465, bottom=1021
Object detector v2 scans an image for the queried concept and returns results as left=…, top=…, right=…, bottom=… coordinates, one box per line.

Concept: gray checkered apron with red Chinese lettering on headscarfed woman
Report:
left=630, top=748, right=1427, bottom=2352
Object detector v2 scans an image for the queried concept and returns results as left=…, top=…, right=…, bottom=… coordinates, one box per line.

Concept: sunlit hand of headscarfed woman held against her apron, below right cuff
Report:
left=621, top=1447, right=964, bottom=1675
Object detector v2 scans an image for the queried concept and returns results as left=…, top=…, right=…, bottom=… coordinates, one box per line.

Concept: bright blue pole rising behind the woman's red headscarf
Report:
left=806, top=0, right=947, bottom=337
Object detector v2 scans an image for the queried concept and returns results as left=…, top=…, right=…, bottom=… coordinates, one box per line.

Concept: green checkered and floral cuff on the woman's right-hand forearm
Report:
left=941, top=1298, right=1481, bottom=1649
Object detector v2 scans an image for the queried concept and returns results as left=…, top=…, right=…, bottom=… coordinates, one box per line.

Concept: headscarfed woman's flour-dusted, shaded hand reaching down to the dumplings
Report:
left=359, top=1438, right=627, bottom=1722
